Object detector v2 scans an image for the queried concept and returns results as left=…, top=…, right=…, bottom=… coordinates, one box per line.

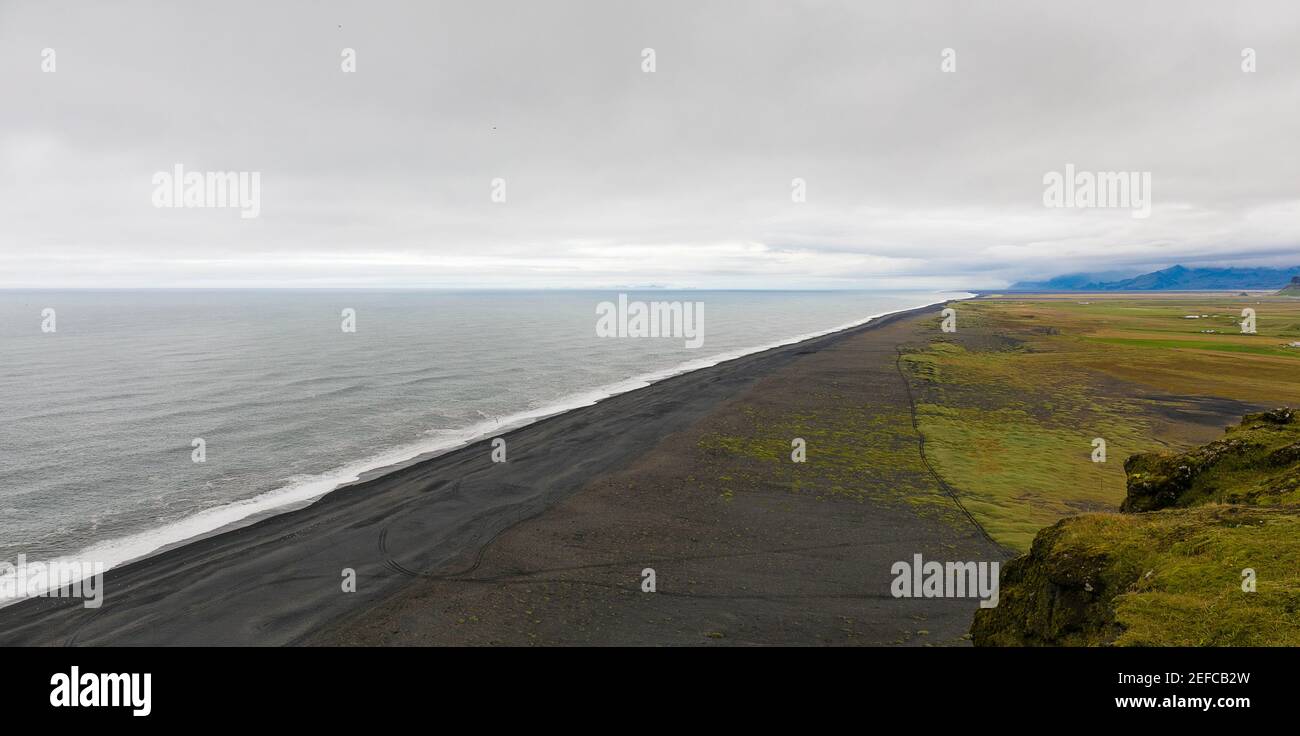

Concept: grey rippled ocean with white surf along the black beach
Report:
left=0, top=290, right=966, bottom=577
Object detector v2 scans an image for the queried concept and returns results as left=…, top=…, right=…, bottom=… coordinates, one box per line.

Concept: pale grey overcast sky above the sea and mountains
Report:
left=0, top=0, right=1300, bottom=287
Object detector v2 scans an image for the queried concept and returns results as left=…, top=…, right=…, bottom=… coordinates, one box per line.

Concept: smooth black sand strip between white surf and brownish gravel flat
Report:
left=0, top=293, right=971, bottom=644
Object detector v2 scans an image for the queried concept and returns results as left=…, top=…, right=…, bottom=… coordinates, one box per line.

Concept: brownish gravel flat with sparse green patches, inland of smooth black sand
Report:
left=312, top=297, right=1009, bottom=646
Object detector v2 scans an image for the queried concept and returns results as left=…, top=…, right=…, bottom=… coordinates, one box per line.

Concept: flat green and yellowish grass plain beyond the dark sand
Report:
left=906, top=294, right=1300, bottom=550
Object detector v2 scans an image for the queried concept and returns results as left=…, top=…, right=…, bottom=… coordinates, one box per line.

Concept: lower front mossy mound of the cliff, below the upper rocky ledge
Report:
left=971, top=505, right=1300, bottom=646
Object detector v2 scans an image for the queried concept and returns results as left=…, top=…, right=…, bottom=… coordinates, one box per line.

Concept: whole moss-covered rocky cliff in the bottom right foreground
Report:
left=971, top=410, right=1300, bottom=646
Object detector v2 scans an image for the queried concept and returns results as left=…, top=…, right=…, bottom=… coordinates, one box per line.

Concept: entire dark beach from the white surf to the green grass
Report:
left=0, top=307, right=1006, bottom=645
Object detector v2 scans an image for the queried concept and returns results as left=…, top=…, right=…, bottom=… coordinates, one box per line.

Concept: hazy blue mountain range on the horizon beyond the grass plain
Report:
left=1011, top=265, right=1300, bottom=291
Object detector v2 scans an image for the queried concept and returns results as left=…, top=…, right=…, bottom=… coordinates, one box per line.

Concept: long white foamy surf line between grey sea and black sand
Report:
left=0, top=291, right=976, bottom=609
